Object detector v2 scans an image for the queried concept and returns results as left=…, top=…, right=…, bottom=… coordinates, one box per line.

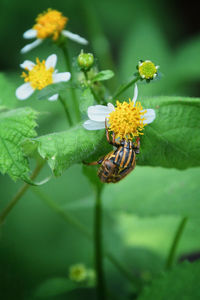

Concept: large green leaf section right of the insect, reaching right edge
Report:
left=138, top=97, right=200, bottom=169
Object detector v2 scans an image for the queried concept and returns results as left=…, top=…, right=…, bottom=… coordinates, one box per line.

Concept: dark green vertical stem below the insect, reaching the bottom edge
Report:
left=94, top=187, right=106, bottom=300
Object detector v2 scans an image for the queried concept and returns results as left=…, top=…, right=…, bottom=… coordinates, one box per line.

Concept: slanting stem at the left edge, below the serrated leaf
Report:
left=0, top=162, right=44, bottom=225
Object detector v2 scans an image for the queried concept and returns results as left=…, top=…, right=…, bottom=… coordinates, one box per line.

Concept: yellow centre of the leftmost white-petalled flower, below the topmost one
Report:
left=22, top=58, right=54, bottom=90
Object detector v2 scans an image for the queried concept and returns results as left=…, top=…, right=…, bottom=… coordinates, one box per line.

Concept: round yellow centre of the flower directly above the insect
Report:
left=108, top=99, right=146, bottom=139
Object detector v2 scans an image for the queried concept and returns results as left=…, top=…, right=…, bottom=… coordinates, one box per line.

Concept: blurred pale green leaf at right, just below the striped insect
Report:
left=103, top=165, right=200, bottom=218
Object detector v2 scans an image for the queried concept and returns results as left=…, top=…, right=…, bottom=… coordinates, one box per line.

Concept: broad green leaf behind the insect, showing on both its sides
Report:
left=30, top=97, right=200, bottom=176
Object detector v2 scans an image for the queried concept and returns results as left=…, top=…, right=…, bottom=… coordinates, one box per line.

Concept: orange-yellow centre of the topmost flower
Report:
left=33, top=8, right=68, bottom=40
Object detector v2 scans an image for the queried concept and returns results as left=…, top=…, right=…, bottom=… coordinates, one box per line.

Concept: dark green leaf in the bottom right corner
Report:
left=138, top=262, right=200, bottom=300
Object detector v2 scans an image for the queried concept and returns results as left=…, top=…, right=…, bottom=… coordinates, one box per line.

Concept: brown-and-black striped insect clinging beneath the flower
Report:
left=87, top=125, right=140, bottom=183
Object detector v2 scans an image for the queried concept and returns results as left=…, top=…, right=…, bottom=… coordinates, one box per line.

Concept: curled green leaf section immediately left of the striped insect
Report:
left=35, top=126, right=109, bottom=176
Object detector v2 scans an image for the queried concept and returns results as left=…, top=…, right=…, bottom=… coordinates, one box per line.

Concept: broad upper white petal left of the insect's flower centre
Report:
left=88, top=103, right=115, bottom=122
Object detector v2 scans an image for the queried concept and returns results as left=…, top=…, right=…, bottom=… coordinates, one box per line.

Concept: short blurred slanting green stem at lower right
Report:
left=165, top=217, right=188, bottom=270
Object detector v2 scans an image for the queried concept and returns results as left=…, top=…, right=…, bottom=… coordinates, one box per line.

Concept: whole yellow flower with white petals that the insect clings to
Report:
left=83, top=85, right=156, bottom=139
